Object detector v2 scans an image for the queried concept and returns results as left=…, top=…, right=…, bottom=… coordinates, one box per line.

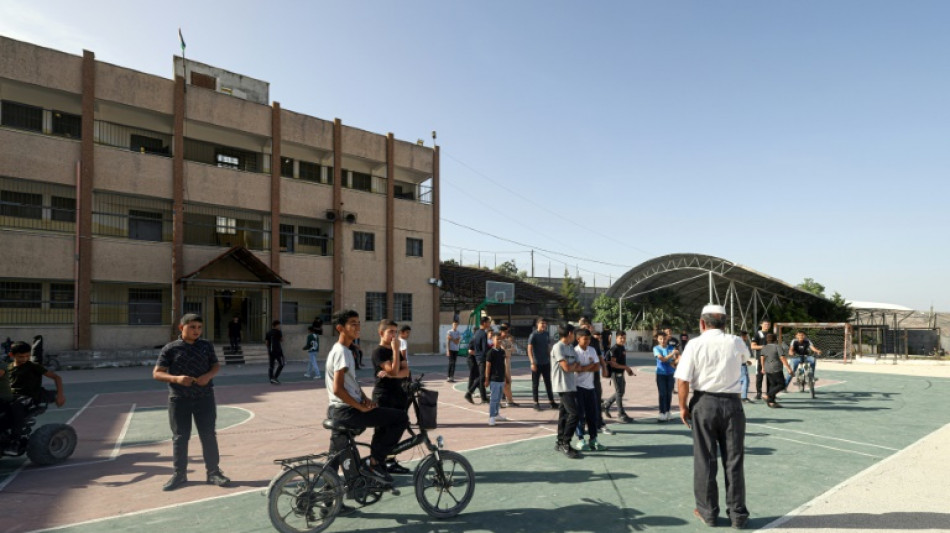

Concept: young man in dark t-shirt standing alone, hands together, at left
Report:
left=152, top=313, right=231, bottom=491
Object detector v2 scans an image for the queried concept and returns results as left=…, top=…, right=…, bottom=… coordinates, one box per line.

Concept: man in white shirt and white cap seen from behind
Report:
left=674, top=305, right=750, bottom=529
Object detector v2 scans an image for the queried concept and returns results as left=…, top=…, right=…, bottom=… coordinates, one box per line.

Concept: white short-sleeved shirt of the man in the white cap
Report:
left=673, top=329, right=750, bottom=393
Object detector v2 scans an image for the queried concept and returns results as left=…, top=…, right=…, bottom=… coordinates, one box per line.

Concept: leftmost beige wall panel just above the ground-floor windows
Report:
left=0, top=229, right=76, bottom=280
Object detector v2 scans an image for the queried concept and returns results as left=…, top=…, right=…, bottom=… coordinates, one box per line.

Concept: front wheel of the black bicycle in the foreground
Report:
left=415, top=450, right=475, bottom=518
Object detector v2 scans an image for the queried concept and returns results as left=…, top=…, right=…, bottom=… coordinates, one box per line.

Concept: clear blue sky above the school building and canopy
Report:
left=0, top=0, right=950, bottom=311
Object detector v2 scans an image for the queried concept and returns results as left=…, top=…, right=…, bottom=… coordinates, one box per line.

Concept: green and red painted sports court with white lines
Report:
left=0, top=357, right=950, bottom=533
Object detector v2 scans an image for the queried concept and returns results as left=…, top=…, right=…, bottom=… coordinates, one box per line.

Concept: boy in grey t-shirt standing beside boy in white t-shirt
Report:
left=551, top=324, right=581, bottom=459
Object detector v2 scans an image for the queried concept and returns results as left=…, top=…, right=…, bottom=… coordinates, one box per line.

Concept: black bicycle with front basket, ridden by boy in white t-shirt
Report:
left=267, top=376, right=475, bottom=533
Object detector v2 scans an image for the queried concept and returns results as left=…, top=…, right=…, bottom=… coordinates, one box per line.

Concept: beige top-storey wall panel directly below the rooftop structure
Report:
left=185, top=85, right=271, bottom=137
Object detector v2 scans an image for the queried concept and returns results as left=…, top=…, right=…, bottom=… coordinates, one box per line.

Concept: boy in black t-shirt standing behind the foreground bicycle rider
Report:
left=373, top=318, right=410, bottom=474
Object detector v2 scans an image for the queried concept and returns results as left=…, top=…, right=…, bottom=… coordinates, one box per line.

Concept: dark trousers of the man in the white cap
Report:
left=690, top=392, right=749, bottom=520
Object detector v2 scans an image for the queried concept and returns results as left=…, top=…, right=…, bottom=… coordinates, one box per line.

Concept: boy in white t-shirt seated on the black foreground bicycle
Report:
left=326, top=310, right=409, bottom=482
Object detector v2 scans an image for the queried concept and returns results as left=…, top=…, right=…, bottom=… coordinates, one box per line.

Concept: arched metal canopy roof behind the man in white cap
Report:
left=607, top=254, right=827, bottom=331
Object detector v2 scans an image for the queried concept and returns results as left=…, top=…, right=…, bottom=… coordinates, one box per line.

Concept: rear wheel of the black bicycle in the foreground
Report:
left=267, top=464, right=343, bottom=533
